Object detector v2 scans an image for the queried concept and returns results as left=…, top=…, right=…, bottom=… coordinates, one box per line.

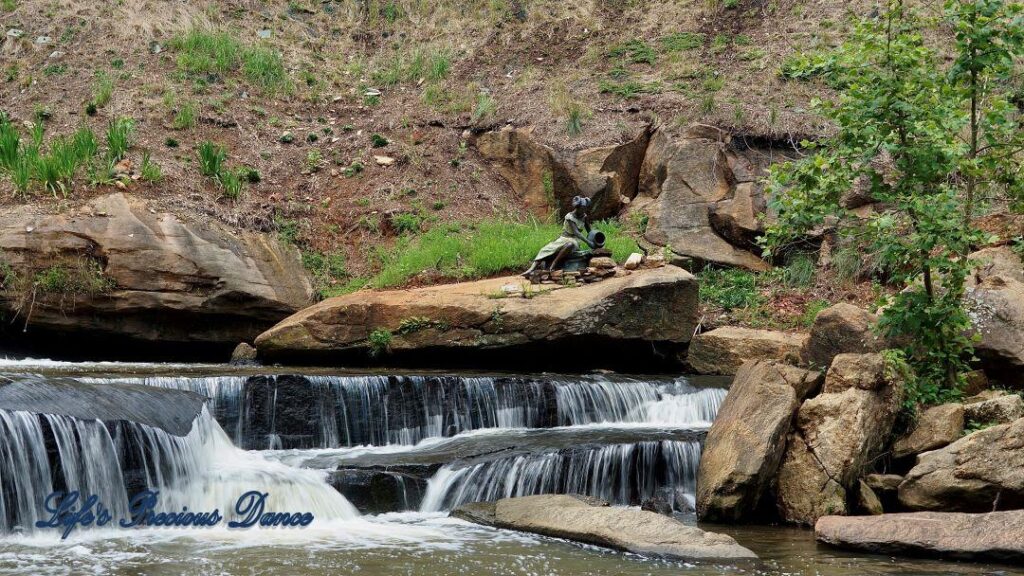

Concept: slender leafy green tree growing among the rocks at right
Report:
left=762, top=0, right=1024, bottom=393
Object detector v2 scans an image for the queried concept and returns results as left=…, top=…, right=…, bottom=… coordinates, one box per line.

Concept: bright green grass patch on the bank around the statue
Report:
left=368, top=219, right=639, bottom=288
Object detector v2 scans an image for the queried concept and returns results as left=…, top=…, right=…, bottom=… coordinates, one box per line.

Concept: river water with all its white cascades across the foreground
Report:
left=0, top=361, right=1024, bottom=576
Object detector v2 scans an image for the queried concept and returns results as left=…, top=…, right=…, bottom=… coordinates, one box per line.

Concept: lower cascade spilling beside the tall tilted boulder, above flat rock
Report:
left=420, top=441, right=700, bottom=511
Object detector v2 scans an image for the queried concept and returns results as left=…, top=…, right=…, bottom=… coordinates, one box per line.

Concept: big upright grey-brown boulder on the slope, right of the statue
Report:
left=630, top=126, right=768, bottom=271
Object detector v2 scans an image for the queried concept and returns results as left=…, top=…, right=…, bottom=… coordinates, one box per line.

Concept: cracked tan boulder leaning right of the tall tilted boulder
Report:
left=777, top=355, right=902, bottom=525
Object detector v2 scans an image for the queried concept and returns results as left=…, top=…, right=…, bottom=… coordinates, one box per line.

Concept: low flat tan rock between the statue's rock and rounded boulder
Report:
left=686, top=326, right=807, bottom=374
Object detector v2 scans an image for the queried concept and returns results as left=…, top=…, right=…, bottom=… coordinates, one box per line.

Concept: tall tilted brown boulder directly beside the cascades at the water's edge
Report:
left=696, top=361, right=820, bottom=522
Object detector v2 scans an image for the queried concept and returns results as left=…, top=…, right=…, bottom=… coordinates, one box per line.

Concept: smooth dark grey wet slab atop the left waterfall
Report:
left=0, top=376, right=206, bottom=436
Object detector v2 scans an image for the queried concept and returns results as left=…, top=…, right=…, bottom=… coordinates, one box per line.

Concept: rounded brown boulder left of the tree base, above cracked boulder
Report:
left=802, top=303, right=884, bottom=367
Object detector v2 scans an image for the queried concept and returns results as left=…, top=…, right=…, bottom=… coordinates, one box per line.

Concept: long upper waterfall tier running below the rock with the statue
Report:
left=90, top=375, right=725, bottom=450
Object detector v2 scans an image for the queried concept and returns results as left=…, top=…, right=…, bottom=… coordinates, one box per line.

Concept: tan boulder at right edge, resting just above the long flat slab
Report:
left=899, top=412, right=1024, bottom=511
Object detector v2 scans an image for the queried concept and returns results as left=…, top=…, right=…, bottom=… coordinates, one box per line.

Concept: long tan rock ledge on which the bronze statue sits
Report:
left=256, top=266, right=697, bottom=359
